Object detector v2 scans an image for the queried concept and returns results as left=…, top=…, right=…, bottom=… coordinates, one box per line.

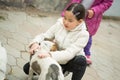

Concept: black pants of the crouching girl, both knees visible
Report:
left=23, top=55, right=87, bottom=80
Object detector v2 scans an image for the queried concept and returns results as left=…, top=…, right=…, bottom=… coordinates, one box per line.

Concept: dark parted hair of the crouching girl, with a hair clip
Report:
left=66, top=3, right=85, bottom=20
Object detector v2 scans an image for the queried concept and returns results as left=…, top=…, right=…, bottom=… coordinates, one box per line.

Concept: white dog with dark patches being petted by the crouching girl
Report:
left=28, top=41, right=64, bottom=80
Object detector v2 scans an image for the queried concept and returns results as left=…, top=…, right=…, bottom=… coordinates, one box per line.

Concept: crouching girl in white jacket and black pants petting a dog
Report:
left=24, top=3, right=89, bottom=80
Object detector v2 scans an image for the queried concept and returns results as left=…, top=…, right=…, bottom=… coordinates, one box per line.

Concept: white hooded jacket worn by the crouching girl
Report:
left=31, top=18, right=89, bottom=64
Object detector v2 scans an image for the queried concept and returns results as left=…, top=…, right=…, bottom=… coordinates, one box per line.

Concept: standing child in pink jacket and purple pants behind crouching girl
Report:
left=62, top=0, right=113, bottom=65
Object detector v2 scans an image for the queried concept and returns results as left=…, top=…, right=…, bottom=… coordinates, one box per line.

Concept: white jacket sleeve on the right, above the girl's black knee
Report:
left=50, top=31, right=89, bottom=64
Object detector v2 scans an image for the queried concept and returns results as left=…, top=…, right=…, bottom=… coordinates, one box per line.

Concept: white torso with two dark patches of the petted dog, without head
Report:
left=30, top=52, right=64, bottom=80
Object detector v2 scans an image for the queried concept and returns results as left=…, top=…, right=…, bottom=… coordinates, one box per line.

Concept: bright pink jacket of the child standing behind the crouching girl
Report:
left=62, top=0, right=113, bottom=36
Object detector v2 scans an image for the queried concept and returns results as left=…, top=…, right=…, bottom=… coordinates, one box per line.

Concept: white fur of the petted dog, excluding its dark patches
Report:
left=28, top=41, right=64, bottom=80
